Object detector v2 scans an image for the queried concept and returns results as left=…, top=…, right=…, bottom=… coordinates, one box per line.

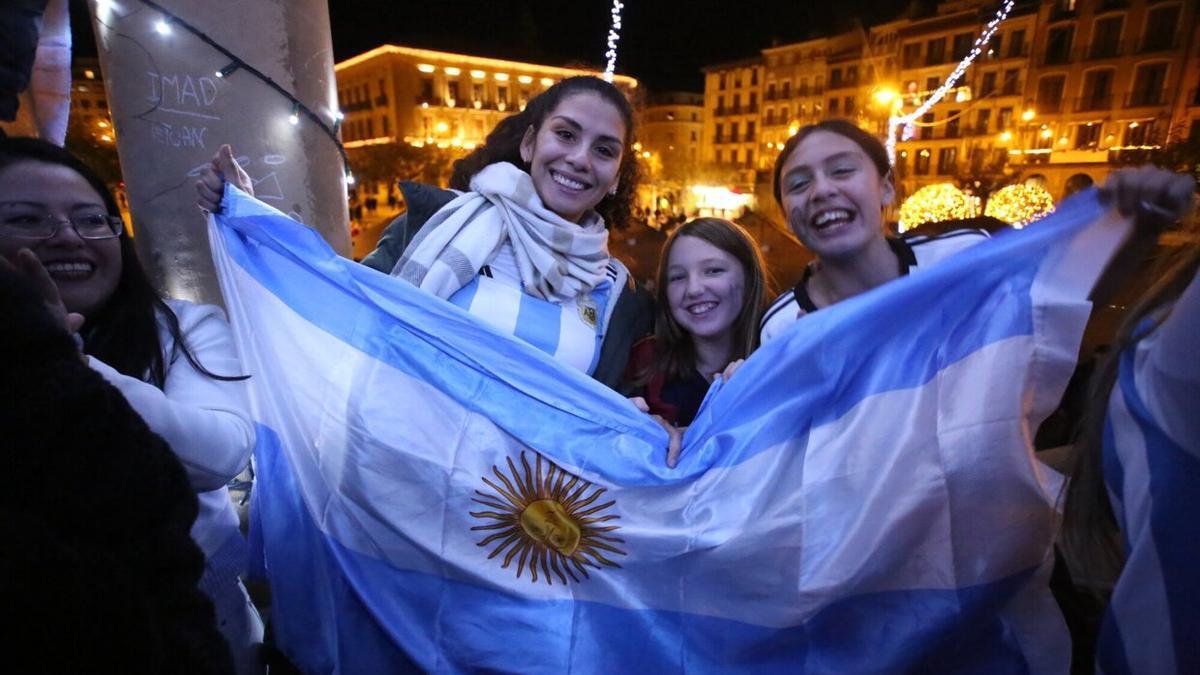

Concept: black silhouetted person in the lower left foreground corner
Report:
left=0, top=254, right=233, bottom=674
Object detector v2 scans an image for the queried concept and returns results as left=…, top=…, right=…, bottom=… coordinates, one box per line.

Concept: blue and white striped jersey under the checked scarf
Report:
left=450, top=241, right=619, bottom=375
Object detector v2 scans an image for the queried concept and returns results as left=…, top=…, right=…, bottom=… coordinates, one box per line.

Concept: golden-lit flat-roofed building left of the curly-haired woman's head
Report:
left=335, top=44, right=637, bottom=149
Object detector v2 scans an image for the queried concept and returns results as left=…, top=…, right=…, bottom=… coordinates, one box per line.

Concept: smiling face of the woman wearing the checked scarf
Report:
left=521, top=91, right=629, bottom=222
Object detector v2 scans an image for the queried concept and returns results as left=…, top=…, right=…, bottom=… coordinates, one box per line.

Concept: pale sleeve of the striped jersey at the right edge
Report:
left=1134, top=267, right=1200, bottom=448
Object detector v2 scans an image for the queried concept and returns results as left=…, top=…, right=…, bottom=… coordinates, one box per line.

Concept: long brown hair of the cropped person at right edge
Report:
left=1058, top=246, right=1200, bottom=590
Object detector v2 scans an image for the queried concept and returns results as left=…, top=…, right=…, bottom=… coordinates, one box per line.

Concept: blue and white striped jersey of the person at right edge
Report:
left=1096, top=270, right=1200, bottom=674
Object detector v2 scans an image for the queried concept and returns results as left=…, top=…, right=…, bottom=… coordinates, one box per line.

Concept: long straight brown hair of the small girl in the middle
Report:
left=638, top=217, right=768, bottom=380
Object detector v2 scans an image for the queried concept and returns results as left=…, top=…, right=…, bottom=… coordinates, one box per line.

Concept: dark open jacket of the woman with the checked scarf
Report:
left=362, top=183, right=654, bottom=389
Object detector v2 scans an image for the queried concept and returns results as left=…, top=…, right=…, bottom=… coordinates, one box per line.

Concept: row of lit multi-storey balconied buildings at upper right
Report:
left=702, top=0, right=1200, bottom=205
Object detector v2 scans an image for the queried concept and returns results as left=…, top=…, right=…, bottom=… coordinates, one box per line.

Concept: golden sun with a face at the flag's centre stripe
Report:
left=470, top=452, right=625, bottom=584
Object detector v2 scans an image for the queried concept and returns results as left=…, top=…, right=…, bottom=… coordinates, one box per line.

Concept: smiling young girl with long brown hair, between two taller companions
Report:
left=626, top=217, right=767, bottom=426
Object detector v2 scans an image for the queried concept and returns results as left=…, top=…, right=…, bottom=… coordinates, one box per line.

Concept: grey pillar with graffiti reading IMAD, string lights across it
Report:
left=90, top=0, right=350, bottom=304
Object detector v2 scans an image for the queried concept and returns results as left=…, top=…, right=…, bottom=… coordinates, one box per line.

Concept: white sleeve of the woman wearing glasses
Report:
left=88, top=303, right=254, bottom=491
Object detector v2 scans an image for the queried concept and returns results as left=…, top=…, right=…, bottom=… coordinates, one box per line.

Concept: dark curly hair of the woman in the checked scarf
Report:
left=450, top=76, right=641, bottom=229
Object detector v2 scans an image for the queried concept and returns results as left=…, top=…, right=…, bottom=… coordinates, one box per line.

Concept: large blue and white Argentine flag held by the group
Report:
left=210, top=187, right=1128, bottom=674
